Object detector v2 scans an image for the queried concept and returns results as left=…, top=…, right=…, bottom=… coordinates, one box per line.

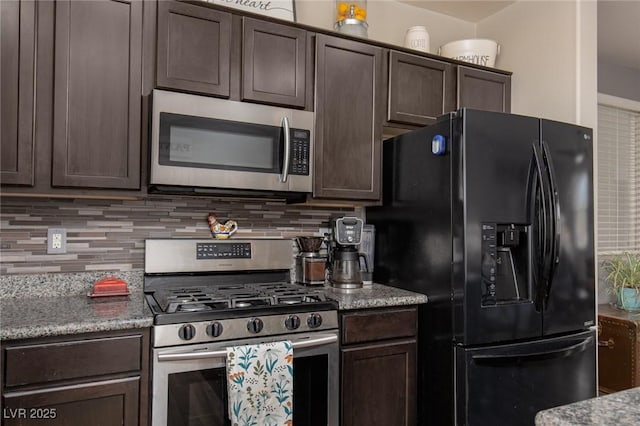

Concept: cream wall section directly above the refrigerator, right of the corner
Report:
left=477, top=1, right=597, bottom=129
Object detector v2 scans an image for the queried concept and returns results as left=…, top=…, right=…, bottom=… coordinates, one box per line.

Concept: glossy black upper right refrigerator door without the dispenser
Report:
left=542, top=120, right=596, bottom=335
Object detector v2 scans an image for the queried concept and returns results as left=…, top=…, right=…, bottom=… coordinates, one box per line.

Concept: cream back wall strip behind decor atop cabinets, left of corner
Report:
left=296, top=0, right=476, bottom=53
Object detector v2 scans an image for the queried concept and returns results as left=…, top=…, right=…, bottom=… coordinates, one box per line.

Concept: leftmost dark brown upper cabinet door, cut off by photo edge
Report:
left=0, top=0, right=36, bottom=185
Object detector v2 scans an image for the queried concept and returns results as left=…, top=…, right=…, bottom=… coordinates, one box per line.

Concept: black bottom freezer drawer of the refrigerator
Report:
left=455, top=330, right=596, bottom=426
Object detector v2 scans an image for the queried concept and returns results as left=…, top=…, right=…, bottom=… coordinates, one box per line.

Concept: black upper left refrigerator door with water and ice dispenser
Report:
left=452, top=110, right=546, bottom=346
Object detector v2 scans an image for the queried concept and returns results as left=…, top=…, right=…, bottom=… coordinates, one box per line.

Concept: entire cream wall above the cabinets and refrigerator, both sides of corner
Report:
left=296, top=0, right=598, bottom=129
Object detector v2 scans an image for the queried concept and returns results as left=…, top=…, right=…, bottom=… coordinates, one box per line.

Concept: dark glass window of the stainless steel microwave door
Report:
left=159, top=113, right=284, bottom=173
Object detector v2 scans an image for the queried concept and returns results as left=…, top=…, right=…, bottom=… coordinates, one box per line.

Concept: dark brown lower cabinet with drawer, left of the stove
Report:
left=2, top=329, right=149, bottom=426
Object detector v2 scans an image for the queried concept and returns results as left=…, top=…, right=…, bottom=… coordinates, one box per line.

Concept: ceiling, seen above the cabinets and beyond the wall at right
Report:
left=398, top=0, right=640, bottom=72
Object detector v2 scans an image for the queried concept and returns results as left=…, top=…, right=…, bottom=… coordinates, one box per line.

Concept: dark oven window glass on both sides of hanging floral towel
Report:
left=167, top=355, right=329, bottom=426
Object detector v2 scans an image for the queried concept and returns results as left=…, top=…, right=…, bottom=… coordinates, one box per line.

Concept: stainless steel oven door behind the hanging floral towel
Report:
left=151, top=331, right=339, bottom=426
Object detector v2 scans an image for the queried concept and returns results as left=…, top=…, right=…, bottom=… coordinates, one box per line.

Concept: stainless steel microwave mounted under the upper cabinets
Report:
left=149, top=90, right=313, bottom=193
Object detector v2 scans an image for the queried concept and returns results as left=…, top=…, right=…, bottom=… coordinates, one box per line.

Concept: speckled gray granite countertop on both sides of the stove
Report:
left=0, top=272, right=427, bottom=340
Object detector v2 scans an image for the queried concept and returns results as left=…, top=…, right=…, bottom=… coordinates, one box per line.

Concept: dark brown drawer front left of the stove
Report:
left=4, top=335, right=142, bottom=387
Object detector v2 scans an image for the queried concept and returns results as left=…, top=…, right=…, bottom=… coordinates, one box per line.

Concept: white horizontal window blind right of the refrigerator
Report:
left=597, top=104, right=640, bottom=255
